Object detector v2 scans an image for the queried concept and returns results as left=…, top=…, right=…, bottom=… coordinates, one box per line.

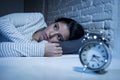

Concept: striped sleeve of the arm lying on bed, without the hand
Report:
left=0, top=41, right=47, bottom=57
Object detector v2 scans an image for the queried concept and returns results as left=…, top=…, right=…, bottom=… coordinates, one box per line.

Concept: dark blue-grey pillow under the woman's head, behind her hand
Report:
left=60, top=38, right=82, bottom=54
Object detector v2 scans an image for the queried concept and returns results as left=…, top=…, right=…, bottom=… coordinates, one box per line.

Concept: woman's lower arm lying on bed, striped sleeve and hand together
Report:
left=0, top=41, right=63, bottom=57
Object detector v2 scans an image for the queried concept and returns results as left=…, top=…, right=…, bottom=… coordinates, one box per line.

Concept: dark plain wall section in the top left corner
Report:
left=0, top=0, right=24, bottom=16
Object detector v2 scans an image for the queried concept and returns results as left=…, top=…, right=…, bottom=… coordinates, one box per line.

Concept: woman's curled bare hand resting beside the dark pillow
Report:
left=44, top=43, right=63, bottom=57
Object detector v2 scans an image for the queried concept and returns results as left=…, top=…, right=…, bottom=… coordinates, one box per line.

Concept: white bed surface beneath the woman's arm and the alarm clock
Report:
left=0, top=54, right=120, bottom=80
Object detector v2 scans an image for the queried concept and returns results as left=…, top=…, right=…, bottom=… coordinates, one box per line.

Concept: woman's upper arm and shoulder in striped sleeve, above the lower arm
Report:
left=0, top=13, right=46, bottom=42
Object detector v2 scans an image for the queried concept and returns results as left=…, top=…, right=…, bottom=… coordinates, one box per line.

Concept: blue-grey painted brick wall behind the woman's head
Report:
left=47, top=0, right=114, bottom=35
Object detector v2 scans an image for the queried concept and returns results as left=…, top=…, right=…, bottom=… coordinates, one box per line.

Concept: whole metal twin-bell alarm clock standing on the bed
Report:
left=78, top=33, right=112, bottom=74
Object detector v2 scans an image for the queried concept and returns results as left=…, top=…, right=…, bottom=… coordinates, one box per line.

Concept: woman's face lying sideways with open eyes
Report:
left=39, top=22, right=70, bottom=42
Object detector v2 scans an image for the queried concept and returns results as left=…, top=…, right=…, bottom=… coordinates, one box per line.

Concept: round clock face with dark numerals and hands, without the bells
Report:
left=79, top=42, right=109, bottom=70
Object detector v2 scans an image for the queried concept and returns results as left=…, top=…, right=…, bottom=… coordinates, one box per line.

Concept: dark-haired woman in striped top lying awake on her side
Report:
left=0, top=13, right=84, bottom=57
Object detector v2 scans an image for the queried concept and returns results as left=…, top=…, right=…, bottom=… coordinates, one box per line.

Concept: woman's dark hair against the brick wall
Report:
left=55, top=17, right=84, bottom=40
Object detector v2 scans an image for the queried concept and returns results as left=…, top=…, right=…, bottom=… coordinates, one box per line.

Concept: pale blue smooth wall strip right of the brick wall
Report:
left=114, top=0, right=120, bottom=58
